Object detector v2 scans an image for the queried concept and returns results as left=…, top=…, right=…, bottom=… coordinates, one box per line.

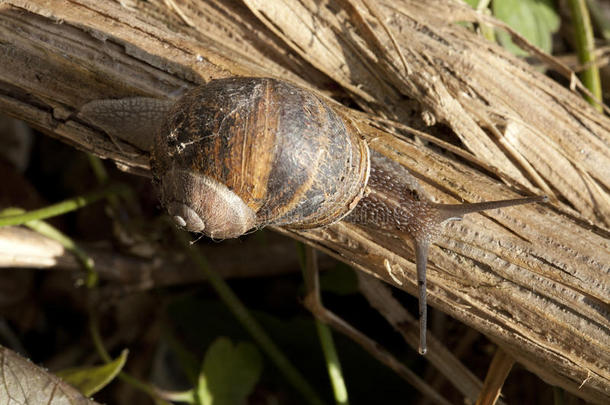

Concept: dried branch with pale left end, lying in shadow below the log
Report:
left=0, top=227, right=304, bottom=282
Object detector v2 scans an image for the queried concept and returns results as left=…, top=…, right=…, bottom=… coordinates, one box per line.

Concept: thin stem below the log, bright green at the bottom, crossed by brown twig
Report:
left=297, top=243, right=349, bottom=405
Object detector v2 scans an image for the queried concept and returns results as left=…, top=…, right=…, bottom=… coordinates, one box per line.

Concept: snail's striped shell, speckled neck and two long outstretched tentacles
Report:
left=79, top=77, right=544, bottom=354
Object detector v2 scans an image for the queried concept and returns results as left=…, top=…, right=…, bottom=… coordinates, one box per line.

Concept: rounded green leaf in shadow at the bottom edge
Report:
left=197, top=338, right=263, bottom=405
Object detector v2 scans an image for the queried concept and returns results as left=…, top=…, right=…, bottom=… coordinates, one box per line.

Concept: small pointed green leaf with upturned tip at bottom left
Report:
left=56, top=349, right=129, bottom=397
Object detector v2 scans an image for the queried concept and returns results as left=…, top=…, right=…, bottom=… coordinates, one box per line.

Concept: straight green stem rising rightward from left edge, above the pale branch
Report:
left=0, top=184, right=129, bottom=227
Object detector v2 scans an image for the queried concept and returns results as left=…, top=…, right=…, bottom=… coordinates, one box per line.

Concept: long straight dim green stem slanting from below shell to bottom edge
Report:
left=176, top=230, right=323, bottom=404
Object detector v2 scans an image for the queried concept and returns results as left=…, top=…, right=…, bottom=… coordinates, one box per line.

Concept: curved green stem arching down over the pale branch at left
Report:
left=0, top=207, right=98, bottom=288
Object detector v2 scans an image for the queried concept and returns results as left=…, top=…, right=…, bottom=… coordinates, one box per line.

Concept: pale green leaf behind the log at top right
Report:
left=492, top=0, right=560, bottom=56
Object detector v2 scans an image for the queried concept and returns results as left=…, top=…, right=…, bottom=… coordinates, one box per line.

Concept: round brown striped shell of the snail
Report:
left=151, top=77, right=369, bottom=238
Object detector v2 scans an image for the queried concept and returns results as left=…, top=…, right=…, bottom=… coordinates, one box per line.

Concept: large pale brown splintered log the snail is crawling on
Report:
left=0, top=0, right=610, bottom=403
